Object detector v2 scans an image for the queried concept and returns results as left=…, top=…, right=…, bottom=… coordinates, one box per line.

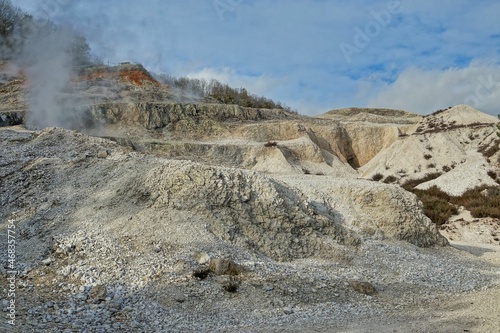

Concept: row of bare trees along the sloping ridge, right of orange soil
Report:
left=158, top=75, right=296, bottom=113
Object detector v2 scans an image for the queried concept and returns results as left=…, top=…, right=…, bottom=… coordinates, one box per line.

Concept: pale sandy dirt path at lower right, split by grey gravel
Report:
left=344, top=218, right=500, bottom=333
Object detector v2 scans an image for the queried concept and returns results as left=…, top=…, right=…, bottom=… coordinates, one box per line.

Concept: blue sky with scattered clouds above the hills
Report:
left=12, top=0, right=500, bottom=115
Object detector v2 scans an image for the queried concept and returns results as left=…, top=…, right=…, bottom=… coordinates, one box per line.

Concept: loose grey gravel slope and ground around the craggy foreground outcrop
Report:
left=0, top=126, right=500, bottom=332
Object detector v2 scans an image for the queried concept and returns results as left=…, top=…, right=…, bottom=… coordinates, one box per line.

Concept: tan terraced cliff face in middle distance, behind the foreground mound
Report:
left=80, top=103, right=415, bottom=175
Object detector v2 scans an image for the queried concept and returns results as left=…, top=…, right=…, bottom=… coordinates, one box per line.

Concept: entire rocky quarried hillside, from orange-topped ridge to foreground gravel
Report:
left=0, top=64, right=500, bottom=332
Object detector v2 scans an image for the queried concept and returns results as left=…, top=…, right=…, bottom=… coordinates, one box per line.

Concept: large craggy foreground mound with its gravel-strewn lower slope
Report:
left=0, top=127, right=492, bottom=332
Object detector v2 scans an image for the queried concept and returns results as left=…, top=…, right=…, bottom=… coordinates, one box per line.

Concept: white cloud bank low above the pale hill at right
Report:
left=365, top=62, right=500, bottom=115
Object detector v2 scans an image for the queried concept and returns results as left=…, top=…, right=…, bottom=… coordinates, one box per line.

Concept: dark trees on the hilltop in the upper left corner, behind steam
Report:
left=0, top=0, right=96, bottom=66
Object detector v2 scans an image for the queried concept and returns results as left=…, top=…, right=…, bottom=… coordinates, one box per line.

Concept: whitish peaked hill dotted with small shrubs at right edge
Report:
left=360, top=105, right=500, bottom=196
